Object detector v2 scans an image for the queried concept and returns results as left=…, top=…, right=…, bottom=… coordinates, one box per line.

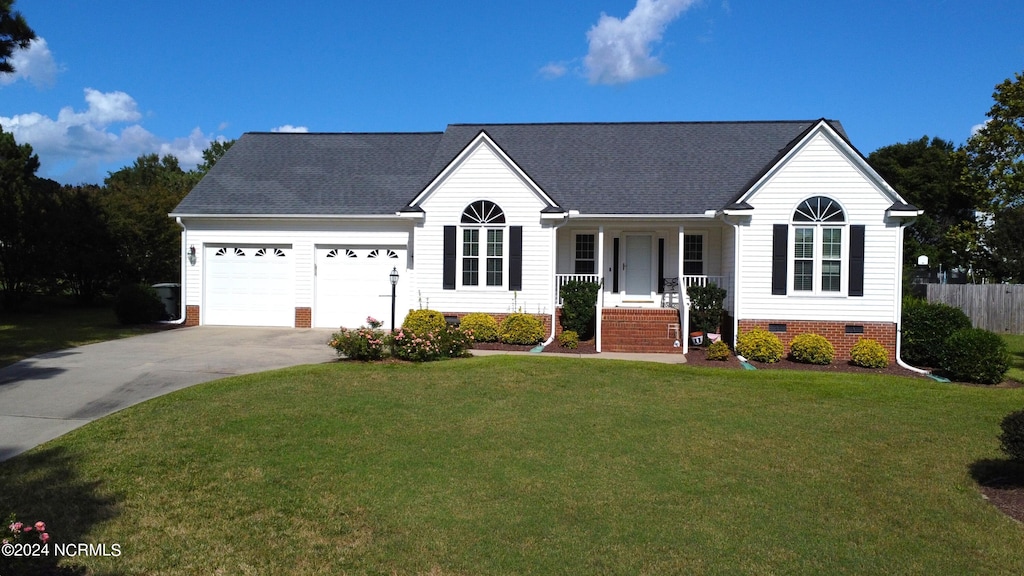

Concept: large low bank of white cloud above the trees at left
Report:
left=0, top=88, right=218, bottom=183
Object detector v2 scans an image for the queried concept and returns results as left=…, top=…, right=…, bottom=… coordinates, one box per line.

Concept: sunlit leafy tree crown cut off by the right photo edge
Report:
left=967, top=73, right=1024, bottom=213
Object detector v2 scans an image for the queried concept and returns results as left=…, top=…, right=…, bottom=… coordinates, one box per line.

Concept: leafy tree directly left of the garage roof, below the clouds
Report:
left=101, top=154, right=199, bottom=284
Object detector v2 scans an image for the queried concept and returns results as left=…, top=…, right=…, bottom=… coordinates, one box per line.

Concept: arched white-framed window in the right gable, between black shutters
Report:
left=793, top=196, right=846, bottom=294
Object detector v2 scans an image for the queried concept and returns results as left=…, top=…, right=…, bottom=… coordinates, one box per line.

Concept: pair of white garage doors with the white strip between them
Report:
left=202, top=244, right=409, bottom=328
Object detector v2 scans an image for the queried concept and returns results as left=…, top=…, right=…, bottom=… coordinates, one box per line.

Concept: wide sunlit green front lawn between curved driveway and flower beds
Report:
left=0, top=357, right=1024, bottom=575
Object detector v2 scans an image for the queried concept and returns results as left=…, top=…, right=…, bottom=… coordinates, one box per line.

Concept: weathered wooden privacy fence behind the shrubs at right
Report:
left=928, top=284, right=1024, bottom=334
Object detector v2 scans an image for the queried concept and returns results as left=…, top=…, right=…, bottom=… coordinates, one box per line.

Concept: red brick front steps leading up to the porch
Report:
left=601, top=308, right=685, bottom=354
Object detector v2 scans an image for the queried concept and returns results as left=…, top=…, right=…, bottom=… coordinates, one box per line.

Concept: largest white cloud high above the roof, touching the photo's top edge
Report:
left=584, top=0, right=697, bottom=84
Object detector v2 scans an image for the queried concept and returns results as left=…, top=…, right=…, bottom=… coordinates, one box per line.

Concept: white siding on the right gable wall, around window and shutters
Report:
left=737, top=132, right=901, bottom=322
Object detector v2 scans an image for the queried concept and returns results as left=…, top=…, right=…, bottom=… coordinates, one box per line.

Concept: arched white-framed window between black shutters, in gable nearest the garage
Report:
left=462, top=200, right=505, bottom=286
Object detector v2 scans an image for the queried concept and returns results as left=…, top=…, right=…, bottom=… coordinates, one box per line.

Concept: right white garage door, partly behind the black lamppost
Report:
left=313, top=246, right=409, bottom=328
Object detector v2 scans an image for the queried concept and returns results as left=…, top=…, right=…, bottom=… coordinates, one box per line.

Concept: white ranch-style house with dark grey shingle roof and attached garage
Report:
left=170, top=119, right=920, bottom=358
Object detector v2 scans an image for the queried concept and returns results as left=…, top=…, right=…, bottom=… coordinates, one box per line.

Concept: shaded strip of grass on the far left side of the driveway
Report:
left=0, top=306, right=161, bottom=367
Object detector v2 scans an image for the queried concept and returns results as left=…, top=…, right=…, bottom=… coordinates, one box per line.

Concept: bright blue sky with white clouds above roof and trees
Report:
left=0, top=0, right=1024, bottom=183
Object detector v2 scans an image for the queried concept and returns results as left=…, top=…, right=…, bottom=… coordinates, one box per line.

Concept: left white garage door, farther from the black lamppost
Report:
left=203, top=245, right=295, bottom=326
